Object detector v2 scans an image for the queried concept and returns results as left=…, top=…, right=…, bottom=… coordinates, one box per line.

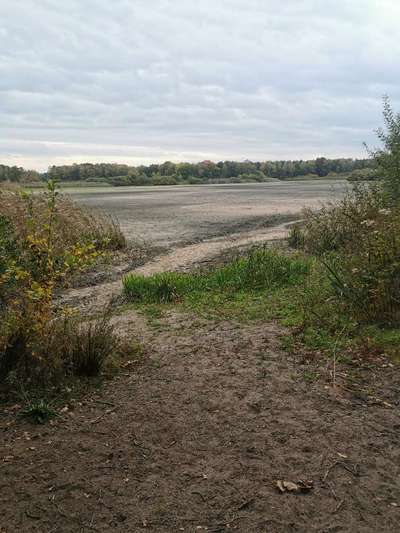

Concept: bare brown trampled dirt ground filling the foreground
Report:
left=0, top=313, right=400, bottom=533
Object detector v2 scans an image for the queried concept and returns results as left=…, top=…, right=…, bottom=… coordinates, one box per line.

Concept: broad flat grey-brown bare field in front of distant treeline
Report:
left=68, top=180, right=348, bottom=248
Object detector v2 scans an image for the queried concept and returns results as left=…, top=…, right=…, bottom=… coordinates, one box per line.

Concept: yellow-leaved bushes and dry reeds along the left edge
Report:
left=0, top=182, right=122, bottom=382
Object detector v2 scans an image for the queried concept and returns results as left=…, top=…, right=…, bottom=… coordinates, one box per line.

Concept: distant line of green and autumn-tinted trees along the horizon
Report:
left=0, top=157, right=375, bottom=186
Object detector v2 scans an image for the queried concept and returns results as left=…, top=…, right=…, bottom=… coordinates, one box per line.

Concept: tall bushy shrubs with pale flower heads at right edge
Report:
left=291, top=98, right=400, bottom=325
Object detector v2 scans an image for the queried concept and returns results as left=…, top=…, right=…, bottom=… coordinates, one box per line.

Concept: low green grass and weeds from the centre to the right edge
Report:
left=124, top=244, right=400, bottom=362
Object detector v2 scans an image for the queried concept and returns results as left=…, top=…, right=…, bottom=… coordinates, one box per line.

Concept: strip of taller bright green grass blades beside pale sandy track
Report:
left=123, top=248, right=309, bottom=303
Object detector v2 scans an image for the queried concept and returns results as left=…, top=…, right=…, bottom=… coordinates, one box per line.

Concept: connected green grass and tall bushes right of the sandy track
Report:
left=124, top=96, right=400, bottom=360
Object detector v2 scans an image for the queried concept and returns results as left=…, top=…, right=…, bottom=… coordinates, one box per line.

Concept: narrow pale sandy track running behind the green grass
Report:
left=59, top=218, right=293, bottom=314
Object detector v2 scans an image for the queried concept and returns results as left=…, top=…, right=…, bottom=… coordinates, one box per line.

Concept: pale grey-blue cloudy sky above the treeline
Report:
left=0, top=0, right=400, bottom=169
